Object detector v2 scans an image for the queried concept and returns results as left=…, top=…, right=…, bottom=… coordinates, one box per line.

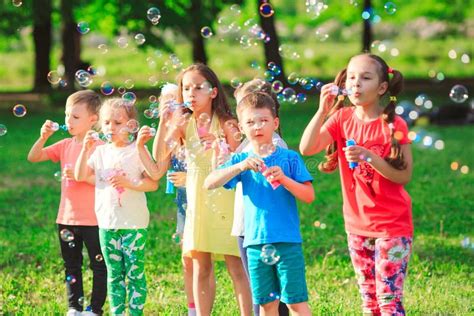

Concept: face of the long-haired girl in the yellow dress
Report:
left=182, top=71, right=217, bottom=112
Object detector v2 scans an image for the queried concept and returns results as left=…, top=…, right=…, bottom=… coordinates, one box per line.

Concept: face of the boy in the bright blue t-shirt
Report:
left=239, top=108, right=279, bottom=144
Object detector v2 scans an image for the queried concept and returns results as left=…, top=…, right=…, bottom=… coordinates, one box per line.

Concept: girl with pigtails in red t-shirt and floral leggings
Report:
left=300, top=54, right=413, bottom=315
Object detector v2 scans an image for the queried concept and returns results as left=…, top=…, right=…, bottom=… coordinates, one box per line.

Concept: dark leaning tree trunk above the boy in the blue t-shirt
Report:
left=257, top=0, right=288, bottom=85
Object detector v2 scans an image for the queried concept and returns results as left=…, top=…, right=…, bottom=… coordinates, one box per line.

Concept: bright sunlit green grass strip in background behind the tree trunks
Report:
left=0, top=37, right=474, bottom=92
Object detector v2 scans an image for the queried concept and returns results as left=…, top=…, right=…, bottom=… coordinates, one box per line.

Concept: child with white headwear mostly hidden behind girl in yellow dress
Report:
left=137, top=83, right=215, bottom=316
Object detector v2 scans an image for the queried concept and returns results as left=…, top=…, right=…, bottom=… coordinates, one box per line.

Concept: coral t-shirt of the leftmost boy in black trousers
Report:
left=45, top=138, right=100, bottom=226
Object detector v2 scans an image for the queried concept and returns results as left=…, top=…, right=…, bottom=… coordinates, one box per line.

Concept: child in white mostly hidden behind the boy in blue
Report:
left=231, top=79, right=289, bottom=316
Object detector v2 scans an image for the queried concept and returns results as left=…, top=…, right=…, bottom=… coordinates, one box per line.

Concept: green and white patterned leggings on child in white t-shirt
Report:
left=99, top=228, right=147, bottom=315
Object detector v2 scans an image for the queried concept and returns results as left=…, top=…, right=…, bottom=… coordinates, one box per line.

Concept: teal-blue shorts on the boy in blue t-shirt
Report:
left=247, top=243, right=308, bottom=305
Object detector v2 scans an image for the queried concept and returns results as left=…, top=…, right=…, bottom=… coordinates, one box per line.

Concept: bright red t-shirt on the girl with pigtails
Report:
left=324, top=107, right=413, bottom=237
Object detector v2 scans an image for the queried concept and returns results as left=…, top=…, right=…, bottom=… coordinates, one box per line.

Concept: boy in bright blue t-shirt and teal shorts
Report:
left=205, top=92, right=314, bottom=315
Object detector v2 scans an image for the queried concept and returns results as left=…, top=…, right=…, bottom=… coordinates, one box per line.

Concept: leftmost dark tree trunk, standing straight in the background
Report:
left=33, top=0, right=52, bottom=92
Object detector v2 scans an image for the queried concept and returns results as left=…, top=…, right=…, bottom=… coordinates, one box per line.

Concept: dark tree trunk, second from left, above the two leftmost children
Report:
left=61, top=0, right=83, bottom=90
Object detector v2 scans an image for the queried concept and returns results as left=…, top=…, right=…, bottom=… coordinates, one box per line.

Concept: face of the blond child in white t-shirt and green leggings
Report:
left=100, top=107, right=130, bottom=144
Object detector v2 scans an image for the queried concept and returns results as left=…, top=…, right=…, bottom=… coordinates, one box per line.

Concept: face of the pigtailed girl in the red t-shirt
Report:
left=346, top=55, right=388, bottom=106
